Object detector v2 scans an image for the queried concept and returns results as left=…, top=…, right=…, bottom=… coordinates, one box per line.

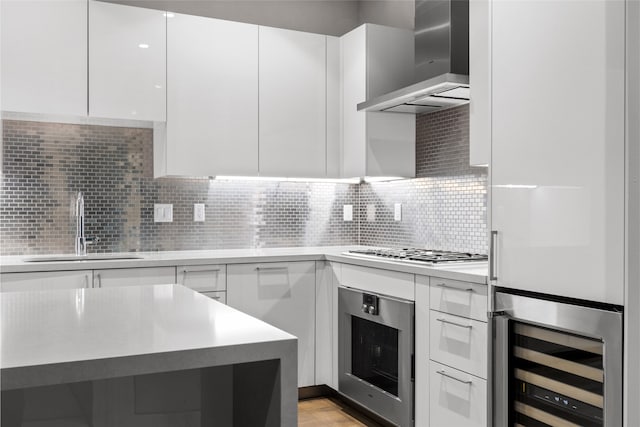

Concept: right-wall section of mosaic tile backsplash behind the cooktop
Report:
left=359, top=106, right=487, bottom=253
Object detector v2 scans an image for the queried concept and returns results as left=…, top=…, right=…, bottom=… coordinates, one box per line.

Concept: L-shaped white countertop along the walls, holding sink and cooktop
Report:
left=0, top=246, right=487, bottom=284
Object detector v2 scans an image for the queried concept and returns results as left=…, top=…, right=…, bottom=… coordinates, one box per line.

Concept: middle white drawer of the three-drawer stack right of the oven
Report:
left=429, top=310, right=487, bottom=378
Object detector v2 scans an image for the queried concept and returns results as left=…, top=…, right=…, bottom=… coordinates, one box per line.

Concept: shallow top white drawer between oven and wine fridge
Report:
left=430, top=277, right=487, bottom=322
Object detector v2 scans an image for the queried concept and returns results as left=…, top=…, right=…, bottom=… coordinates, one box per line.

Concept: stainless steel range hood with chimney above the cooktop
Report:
left=358, top=0, right=469, bottom=113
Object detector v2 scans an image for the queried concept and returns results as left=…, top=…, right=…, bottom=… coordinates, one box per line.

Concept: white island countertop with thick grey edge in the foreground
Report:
left=0, top=285, right=296, bottom=389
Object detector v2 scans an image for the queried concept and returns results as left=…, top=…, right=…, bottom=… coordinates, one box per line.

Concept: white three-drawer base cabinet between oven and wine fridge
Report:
left=415, top=276, right=488, bottom=427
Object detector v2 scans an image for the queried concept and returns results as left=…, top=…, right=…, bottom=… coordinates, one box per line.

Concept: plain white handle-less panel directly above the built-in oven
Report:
left=340, top=264, right=415, bottom=301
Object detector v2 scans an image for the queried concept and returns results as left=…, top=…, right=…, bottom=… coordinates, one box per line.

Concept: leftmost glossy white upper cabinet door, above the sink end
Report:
left=0, top=0, right=87, bottom=116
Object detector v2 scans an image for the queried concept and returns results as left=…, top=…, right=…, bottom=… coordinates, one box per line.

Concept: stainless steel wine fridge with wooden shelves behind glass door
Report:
left=493, top=291, right=623, bottom=427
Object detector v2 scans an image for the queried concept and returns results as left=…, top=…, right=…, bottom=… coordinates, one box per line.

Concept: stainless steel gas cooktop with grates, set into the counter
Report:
left=347, top=248, right=488, bottom=265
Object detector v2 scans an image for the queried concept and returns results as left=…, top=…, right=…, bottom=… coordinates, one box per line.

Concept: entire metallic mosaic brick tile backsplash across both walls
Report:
left=0, top=106, right=487, bottom=255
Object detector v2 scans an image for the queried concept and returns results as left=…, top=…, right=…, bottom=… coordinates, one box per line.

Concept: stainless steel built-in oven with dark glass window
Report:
left=338, top=287, right=414, bottom=426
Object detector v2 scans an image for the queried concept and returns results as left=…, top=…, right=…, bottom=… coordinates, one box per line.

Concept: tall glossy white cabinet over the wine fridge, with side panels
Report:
left=470, top=0, right=640, bottom=426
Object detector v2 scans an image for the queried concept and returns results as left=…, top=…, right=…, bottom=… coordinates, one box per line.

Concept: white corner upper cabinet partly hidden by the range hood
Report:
left=340, top=24, right=416, bottom=177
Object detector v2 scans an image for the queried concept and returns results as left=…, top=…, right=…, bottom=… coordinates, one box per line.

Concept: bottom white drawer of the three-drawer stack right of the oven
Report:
left=429, top=361, right=487, bottom=427
